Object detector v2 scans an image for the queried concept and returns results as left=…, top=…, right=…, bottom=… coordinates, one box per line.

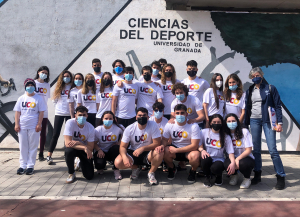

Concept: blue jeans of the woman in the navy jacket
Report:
left=250, top=118, right=285, bottom=177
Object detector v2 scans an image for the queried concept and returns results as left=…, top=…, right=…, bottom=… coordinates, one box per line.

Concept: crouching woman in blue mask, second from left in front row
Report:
left=94, top=111, right=124, bottom=180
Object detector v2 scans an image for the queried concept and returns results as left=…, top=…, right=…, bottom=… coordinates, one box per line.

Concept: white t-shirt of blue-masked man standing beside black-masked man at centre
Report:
left=113, top=82, right=139, bottom=119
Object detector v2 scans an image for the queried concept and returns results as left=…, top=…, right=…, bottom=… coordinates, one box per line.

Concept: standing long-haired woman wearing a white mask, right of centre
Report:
left=203, top=73, right=225, bottom=128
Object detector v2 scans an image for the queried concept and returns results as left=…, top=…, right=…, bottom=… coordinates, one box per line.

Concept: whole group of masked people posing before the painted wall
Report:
left=14, top=59, right=285, bottom=190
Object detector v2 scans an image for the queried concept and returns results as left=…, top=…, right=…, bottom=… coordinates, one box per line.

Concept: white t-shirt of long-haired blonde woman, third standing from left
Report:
left=54, top=84, right=71, bottom=116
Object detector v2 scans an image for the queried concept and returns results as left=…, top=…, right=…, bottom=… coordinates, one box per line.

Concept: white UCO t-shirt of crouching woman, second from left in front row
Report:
left=95, top=124, right=123, bottom=152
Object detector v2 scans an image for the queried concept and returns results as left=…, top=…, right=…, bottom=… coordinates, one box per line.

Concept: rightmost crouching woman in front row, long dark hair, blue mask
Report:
left=224, top=113, right=254, bottom=189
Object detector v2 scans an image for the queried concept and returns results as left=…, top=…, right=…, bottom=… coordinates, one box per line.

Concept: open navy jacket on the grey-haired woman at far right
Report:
left=244, top=82, right=282, bottom=126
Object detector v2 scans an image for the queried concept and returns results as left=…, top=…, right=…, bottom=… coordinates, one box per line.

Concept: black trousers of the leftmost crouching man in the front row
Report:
left=65, top=148, right=94, bottom=180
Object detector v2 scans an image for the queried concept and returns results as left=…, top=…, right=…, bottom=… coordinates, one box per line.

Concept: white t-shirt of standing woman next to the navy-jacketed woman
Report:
left=224, top=93, right=246, bottom=118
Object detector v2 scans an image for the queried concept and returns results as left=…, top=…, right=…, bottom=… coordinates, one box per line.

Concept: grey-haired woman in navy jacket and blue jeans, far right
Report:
left=244, top=67, right=286, bottom=190
